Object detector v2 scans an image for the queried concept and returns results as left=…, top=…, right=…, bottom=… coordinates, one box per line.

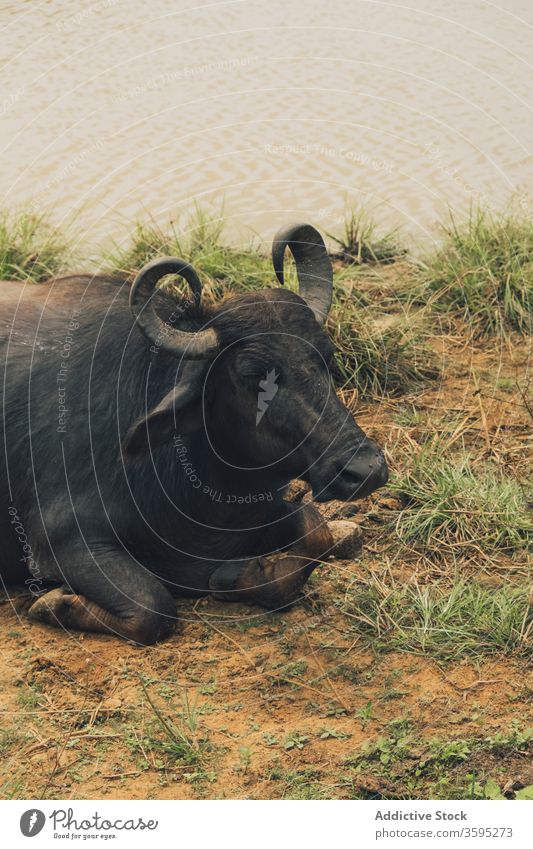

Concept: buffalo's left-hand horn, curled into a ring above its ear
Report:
left=130, top=257, right=218, bottom=360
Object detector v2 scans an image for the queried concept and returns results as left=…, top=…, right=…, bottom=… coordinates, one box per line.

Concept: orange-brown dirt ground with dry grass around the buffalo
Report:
left=0, top=314, right=533, bottom=799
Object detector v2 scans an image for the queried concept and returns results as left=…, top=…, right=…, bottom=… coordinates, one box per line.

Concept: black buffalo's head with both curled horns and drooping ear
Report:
left=126, top=224, right=388, bottom=501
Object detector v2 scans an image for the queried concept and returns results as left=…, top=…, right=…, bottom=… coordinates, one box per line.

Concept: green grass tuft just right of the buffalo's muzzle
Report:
left=389, top=440, right=533, bottom=554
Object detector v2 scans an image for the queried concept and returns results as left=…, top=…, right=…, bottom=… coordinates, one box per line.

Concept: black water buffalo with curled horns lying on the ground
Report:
left=0, top=225, right=387, bottom=644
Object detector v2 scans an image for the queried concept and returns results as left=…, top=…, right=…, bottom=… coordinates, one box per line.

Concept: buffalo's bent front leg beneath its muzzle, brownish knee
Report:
left=209, top=504, right=333, bottom=610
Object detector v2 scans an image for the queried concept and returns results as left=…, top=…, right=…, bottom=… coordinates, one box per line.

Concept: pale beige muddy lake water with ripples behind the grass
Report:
left=0, top=0, right=533, bottom=252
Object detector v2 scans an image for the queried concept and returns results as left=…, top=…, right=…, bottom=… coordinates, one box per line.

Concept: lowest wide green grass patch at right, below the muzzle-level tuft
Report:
left=343, top=575, right=533, bottom=660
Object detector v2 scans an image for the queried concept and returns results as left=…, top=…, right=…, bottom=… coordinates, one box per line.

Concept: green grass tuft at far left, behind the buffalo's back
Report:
left=0, top=212, right=71, bottom=283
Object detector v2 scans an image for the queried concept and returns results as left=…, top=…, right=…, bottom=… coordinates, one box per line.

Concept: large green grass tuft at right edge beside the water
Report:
left=407, top=209, right=533, bottom=336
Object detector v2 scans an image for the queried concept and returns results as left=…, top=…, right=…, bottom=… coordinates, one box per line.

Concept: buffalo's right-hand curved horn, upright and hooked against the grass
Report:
left=272, top=224, right=333, bottom=324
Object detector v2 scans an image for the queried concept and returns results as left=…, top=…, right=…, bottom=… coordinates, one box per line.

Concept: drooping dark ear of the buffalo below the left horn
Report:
left=122, top=363, right=205, bottom=455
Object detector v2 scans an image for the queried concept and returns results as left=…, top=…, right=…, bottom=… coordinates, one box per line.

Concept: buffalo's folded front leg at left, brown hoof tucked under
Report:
left=28, top=552, right=176, bottom=645
